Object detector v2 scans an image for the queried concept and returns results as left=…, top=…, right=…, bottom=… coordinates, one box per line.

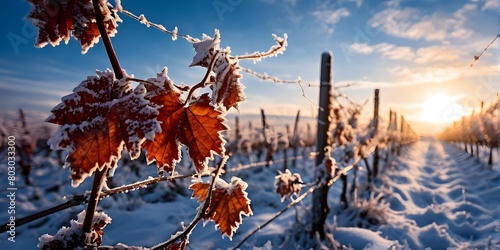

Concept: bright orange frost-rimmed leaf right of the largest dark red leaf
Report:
left=144, top=70, right=227, bottom=174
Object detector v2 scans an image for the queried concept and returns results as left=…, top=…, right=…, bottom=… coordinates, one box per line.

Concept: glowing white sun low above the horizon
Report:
left=421, top=93, right=465, bottom=123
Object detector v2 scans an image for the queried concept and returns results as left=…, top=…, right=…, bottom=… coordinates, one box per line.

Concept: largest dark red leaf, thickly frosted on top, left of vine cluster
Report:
left=46, top=70, right=160, bottom=186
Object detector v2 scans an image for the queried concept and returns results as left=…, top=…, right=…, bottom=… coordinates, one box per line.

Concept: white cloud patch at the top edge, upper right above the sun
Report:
left=368, top=0, right=474, bottom=41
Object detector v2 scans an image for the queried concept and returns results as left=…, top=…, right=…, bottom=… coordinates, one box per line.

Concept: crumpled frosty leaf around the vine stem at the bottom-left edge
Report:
left=38, top=210, right=111, bottom=250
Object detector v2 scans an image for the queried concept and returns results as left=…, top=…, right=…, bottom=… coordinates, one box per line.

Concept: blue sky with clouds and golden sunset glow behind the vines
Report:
left=0, top=0, right=500, bottom=133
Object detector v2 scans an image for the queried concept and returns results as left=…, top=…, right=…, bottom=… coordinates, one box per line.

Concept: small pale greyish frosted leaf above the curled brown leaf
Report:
left=189, top=29, right=220, bottom=68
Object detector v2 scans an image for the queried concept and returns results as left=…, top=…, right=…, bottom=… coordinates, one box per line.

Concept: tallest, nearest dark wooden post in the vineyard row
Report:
left=311, top=52, right=332, bottom=239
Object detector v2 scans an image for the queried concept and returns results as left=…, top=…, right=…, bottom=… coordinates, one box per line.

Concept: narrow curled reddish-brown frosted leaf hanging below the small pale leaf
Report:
left=212, top=50, right=245, bottom=110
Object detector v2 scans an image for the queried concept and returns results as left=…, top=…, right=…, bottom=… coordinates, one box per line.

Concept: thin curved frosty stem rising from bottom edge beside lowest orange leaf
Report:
left=151, top=155, right=229, bottom=250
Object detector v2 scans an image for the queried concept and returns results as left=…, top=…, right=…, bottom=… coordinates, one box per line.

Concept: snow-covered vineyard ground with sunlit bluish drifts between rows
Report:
left=0, top=138, right=500, bottom=249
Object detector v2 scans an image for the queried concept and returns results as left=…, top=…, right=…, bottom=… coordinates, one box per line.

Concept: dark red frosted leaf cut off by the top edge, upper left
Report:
left=28, top=0, right=122, bottom=54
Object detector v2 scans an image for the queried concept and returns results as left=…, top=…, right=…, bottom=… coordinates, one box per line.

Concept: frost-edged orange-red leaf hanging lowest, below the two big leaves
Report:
left=189, top=177, right=252, bottom=239
